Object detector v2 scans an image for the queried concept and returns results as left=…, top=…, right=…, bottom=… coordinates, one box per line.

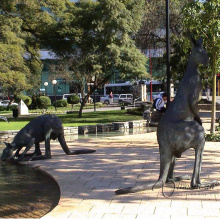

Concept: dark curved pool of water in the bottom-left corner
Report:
left=0, top=145, right=60, bottom=218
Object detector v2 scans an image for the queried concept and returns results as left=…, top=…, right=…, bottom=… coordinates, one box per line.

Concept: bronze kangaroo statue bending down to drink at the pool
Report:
left=1, top=115, right=95, bottom=161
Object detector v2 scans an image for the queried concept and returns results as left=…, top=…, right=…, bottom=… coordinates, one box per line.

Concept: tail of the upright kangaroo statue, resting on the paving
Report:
left=115, top=181, right=163, bottom=195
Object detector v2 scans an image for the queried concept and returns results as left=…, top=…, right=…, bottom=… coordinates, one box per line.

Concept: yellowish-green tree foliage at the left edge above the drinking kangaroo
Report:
left=0, top=0, right=69, bottom=95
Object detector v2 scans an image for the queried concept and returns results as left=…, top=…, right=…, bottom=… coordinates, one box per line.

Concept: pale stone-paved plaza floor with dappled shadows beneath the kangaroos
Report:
left=21, top=121, right=220, bottom=220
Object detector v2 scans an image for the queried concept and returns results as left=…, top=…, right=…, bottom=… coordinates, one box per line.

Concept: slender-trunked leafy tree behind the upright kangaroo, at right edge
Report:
left=183, top=0, right=220, bottom=133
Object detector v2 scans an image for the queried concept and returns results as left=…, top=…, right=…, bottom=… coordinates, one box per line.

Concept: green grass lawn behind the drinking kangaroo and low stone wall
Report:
left=0, top=110, right=143, bottom=131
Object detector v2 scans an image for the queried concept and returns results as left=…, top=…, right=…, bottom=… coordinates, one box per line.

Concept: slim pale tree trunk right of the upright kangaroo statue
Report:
left=210, top=53, right=216, bottom=134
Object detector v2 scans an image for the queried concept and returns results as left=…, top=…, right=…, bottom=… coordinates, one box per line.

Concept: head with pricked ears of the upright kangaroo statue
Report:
left=191, top=37, right=209, bottom=66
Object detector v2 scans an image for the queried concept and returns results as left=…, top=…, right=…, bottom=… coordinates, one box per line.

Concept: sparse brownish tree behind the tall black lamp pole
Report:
left=136, top=0, right=192, bottom=80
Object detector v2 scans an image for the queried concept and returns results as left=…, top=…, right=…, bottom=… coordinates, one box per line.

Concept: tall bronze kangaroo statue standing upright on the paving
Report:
left=115, top=38, right=215, bottom=194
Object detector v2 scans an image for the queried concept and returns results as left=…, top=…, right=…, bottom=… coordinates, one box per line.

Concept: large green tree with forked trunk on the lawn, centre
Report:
left=55, top=0, right=147, bottom=117
